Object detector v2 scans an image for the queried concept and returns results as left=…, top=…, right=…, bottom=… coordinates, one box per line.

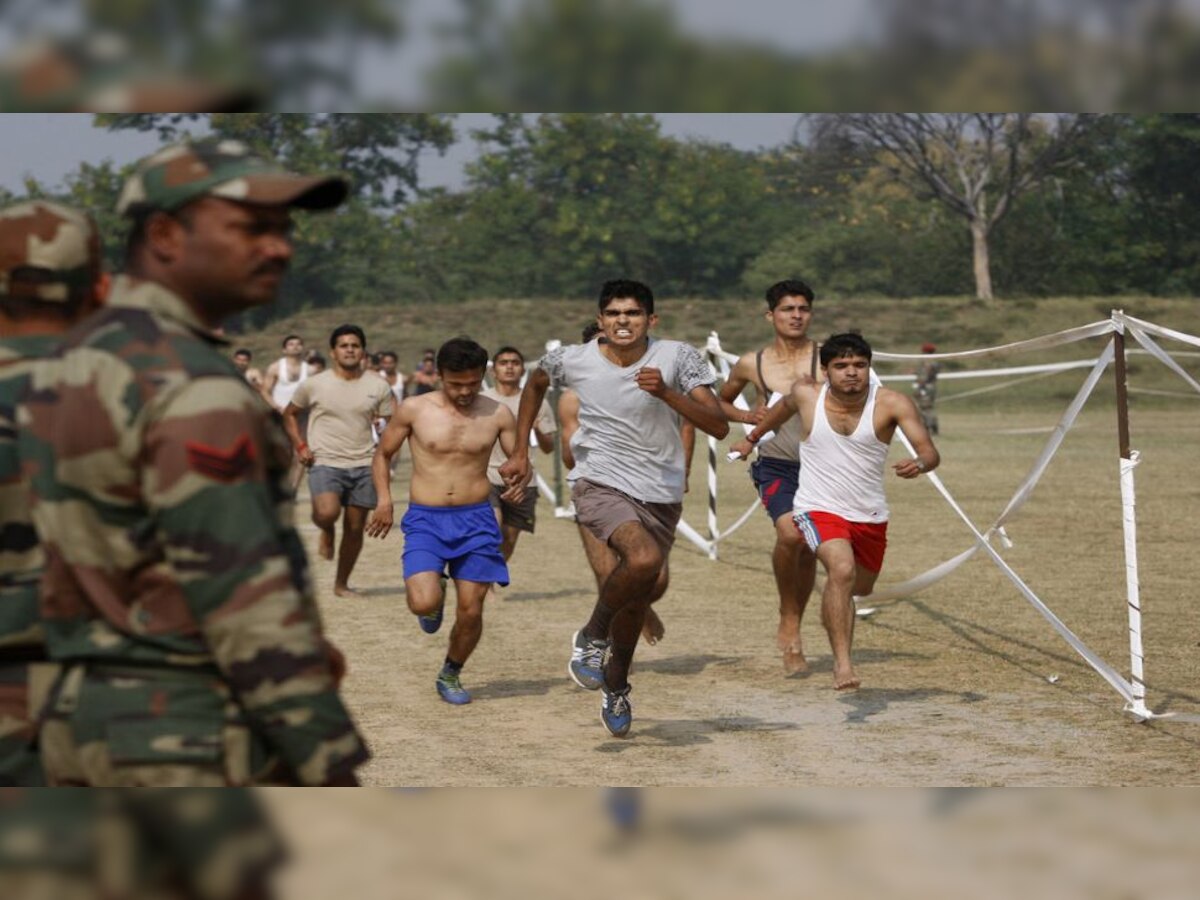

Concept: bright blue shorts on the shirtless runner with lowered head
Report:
left=400, top=500, right=509, bottom=587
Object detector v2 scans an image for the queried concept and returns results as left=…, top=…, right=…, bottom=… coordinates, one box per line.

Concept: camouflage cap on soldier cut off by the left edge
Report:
left=0, top=200, right=100, bottom=302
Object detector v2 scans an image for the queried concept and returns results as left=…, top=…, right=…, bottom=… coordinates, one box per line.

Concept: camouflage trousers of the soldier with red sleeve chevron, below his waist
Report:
left=40, top=664, right=295, bottom=787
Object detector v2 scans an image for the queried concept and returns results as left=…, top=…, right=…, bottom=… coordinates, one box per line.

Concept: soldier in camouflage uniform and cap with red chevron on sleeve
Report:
left=19, top=140, right=368, bottom=786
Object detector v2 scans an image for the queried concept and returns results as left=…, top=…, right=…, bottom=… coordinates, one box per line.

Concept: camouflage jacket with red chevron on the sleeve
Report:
left=18, top=277, right=368, bottom=784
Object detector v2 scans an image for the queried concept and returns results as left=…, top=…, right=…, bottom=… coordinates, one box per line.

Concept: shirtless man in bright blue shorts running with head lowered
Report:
left=366, top=337, right=524, bottom=706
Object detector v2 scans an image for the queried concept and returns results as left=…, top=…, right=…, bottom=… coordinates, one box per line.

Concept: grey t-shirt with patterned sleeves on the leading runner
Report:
left=538, top=338, right=714, bottom=503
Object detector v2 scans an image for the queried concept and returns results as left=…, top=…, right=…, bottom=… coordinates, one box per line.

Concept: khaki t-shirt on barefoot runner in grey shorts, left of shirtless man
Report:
left=292, top=371, right=396, bottom=469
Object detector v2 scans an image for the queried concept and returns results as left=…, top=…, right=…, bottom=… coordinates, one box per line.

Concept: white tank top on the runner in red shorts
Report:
left=792, top=384, right=888, bottom=523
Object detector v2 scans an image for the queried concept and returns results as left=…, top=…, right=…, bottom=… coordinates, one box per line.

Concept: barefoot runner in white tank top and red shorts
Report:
left=750, top=334, right=941, bottom=690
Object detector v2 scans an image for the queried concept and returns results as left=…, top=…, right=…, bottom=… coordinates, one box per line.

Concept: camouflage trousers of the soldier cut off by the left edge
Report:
left=0, top=662, right=59, bottom=787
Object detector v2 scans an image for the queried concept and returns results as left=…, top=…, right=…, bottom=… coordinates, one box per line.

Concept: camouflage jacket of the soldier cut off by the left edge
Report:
left=0, top=336, right=58, bottom=660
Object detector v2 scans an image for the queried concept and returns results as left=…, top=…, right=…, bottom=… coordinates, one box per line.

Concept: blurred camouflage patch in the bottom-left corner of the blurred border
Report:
left=0, top=788, right=283, bottom=900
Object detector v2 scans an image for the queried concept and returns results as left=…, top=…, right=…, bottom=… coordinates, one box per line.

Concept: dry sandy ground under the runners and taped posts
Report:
left=298, top=404, right=1200, bottom=787
